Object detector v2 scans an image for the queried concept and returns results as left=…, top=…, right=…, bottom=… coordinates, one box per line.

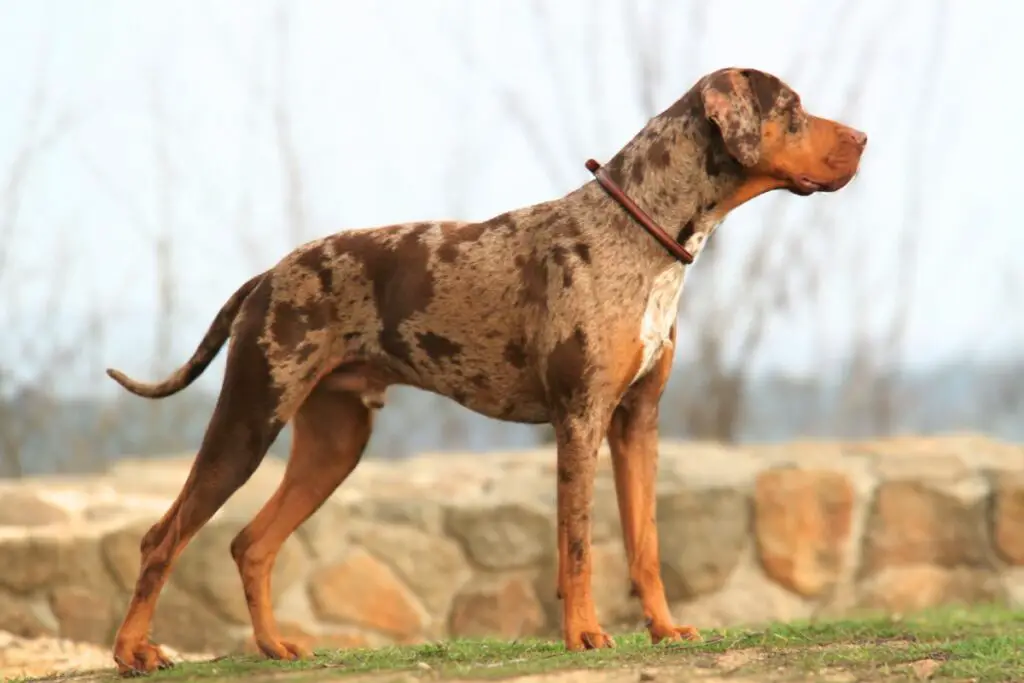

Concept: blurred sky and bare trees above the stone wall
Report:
left=0, top=0, right=1024, bottom=477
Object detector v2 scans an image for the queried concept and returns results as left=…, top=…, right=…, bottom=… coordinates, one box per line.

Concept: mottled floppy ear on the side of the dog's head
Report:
left=700, top=70, right=761, bottom=167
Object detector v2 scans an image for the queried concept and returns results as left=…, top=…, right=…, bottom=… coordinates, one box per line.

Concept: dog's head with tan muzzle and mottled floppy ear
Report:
left=694, top=69, right=867, bottom=196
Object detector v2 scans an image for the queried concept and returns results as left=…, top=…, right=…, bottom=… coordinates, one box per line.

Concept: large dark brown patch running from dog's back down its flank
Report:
left=337, top=223, right=434, bottom=364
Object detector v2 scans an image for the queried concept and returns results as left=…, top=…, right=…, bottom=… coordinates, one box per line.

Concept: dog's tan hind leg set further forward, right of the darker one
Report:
left=231, top=387, right=373, bottom=659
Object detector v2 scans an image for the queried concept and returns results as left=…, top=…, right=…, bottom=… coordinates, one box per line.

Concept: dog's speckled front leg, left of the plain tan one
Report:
left=555, top=418, right=615, bottom=650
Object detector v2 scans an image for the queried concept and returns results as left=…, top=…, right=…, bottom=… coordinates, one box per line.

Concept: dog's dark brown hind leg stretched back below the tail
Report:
left=114, top=281, right=305, bottom=675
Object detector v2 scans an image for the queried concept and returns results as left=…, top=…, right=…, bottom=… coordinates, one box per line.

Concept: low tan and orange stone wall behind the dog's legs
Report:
left=0, top=436, right=1024, bottom=652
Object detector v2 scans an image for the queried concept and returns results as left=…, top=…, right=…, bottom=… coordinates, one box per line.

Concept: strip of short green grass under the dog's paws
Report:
left=24, top=606, right=1024, bottom=683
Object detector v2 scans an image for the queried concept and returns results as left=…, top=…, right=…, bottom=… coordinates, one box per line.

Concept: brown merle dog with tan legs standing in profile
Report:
left=108, top=68, right=867, bottom=675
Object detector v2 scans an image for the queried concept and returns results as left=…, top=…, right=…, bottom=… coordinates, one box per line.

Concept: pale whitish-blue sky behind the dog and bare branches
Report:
left=0, top=0, right=1024, bottom=397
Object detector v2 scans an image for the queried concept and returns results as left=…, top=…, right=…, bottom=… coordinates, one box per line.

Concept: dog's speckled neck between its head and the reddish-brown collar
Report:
left=581, top=93, right=743, bottom=263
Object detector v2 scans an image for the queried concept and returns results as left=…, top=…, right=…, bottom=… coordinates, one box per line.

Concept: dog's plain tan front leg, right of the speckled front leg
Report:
left=608, top=339, right=700, bottom=643
